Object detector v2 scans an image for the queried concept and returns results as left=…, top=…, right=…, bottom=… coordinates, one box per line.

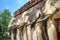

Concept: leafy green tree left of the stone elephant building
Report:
left=0, top=9, right=12, bottom=37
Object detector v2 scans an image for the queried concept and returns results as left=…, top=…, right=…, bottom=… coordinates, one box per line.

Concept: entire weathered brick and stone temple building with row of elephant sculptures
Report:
left=8, top=0, right=60, bottom=40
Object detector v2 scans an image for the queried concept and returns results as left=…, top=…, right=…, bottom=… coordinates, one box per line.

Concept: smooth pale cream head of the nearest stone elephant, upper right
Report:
left=44, top=0, right=56, bottom=15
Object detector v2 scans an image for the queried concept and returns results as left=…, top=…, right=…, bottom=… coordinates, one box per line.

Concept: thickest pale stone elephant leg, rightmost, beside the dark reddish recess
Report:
left=47, top=20, right=58, bottom=40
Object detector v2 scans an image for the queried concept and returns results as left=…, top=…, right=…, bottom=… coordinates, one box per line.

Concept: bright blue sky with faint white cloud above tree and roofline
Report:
left=0, top=0, right=29, bottom=15
